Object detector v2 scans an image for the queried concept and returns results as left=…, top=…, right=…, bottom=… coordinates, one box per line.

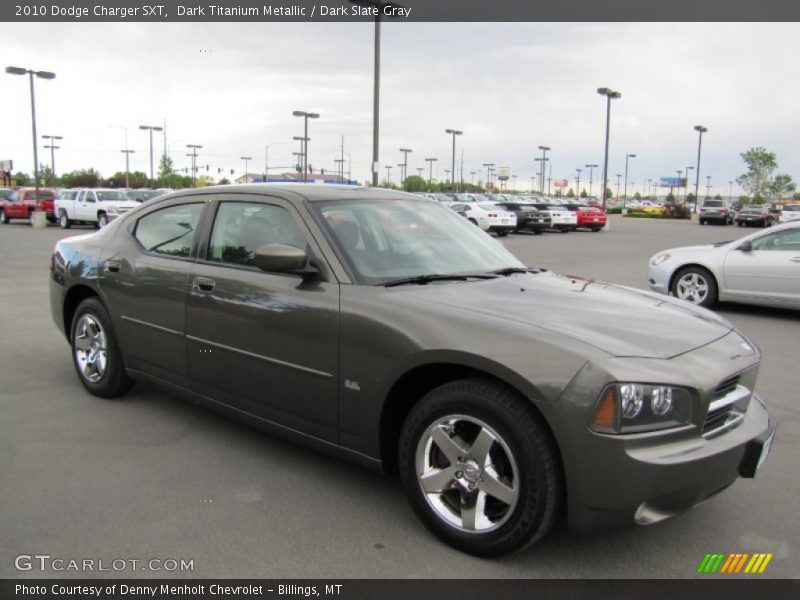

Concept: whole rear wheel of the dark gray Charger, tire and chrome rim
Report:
left=69, top=298, right=133, bottom=398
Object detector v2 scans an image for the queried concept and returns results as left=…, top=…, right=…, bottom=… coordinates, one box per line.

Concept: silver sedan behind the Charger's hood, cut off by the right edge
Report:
left=649, top=220, right=800, bottom=309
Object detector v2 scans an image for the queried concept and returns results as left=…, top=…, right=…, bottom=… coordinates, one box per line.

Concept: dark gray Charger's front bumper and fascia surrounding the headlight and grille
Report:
left=543, top=332, right=775, bottom=530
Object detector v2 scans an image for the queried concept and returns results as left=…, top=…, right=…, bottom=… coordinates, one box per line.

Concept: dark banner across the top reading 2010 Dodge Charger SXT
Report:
left=0, top=0, right=800, bottom=23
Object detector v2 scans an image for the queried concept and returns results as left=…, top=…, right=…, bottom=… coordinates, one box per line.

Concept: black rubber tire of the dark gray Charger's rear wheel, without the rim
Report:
left=69, top=298, right=132, bottom=398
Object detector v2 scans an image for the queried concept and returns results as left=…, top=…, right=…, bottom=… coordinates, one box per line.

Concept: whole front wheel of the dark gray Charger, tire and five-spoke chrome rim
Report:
left=398, top=379, right=564, bottom=557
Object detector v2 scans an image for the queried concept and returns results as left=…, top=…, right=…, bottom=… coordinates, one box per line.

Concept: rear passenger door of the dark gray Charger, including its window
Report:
left=99, top=196, right=206, bottom=388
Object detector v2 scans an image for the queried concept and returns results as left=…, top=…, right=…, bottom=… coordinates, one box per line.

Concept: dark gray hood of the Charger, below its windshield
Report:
left=404, top=271, right=733, bottom=358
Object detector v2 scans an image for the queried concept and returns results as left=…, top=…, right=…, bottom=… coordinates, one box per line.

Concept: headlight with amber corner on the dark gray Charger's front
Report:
left=592, top=383, right=692, bottom=433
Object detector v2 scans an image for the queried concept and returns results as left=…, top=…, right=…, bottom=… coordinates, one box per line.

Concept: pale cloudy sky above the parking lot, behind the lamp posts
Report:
left=0, top=23, right=800, bottom=196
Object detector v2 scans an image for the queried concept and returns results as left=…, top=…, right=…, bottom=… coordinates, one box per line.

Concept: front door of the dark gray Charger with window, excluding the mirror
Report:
left=186, top=195, right=339, bottom=442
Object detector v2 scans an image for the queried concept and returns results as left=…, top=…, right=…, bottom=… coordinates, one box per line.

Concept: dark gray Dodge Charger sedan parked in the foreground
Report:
left=50, top=185, right=775, bottom=556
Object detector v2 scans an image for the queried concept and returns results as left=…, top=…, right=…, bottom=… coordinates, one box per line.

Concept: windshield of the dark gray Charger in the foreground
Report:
left=310, top=198, right=524, bottom=285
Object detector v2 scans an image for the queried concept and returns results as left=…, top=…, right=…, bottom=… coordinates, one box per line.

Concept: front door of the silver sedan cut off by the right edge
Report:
left=724, top=228, right=800, bottom=304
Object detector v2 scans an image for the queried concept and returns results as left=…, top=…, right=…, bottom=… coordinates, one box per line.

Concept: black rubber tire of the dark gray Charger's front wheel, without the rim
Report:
left=399, top=380, right=560, bottom=557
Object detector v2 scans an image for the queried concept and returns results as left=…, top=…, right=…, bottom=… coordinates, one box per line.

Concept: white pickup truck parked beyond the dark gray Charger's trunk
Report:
left=55, top=188, right=139, bottom=229
